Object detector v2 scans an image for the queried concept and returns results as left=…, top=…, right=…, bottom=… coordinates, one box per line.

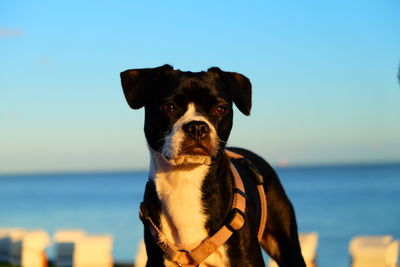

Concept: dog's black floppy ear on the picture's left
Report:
left=121, top=65, right=173, bottom=109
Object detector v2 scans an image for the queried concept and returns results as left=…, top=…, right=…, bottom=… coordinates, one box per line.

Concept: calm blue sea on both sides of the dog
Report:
left=0, top=164, right=400, bottom=267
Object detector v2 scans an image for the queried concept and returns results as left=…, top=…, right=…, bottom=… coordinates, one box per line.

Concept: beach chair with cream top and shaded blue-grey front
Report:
left=54, top=229, right=86, bottom=267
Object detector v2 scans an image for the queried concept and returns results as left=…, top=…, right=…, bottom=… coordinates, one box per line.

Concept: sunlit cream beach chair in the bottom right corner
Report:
left=349, top=235, right=399, bottom=267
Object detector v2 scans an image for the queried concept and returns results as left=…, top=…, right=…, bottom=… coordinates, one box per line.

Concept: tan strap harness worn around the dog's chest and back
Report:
left=139, top=150, right=267, bottom=267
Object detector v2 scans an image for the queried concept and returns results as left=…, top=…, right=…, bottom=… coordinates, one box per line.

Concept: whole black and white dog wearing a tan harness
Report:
left=120, top=65, right=305, bottom=267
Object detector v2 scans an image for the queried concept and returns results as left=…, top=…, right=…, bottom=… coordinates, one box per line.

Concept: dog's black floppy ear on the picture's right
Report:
left=208, top=67, right=251, bottom=116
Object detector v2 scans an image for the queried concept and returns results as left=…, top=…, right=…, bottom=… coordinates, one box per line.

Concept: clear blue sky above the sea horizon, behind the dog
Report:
left=0, top=0, right=400, bottom=173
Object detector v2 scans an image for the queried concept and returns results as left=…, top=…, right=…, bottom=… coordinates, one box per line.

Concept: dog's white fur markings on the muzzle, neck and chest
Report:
left=150, top=103, right=228, bottom=267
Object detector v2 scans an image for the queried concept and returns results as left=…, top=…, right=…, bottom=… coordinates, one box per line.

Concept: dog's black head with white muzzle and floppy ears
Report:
left=121, top=65, right=251, bottom=165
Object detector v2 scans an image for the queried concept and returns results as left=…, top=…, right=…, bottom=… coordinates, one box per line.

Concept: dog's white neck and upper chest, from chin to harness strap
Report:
left=149, top=151, right=210, bottom=250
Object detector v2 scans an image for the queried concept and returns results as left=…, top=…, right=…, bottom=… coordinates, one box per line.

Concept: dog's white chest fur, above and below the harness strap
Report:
left=154, top=165, right=227, bottom=266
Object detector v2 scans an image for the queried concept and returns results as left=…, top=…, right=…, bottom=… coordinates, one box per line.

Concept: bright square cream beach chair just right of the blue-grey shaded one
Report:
left=73, top=235, right=113, bottom=267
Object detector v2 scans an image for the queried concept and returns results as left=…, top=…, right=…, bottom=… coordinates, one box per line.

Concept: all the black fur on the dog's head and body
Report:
left=121, top=65, right=305, bottom=267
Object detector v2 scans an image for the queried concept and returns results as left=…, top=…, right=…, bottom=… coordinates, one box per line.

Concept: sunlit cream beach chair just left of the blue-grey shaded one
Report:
left=10, top=230, right=50, bottom=267
